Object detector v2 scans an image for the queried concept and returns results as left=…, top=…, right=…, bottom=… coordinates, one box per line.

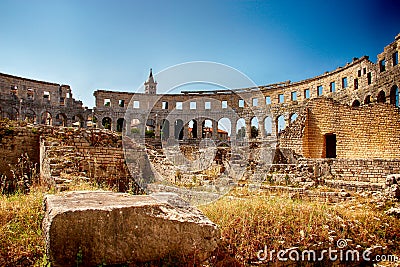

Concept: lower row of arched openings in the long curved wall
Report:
left=101, top=113, right=298, bottom=140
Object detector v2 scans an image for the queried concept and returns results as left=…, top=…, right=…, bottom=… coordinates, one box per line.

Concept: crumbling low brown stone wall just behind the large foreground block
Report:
left=41, top=128, right=132, bottom=191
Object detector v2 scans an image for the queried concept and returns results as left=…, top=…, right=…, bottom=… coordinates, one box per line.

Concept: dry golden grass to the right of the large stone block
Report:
left=202, top=191, right=400, bottom=265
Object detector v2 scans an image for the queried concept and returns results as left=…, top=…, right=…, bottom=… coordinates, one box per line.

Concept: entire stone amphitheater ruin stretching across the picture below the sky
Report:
left=0, top=35, right=400, bottom=197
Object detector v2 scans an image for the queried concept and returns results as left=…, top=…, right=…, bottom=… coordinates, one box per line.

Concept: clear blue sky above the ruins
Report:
left=0, top=0, right=400, bottom=107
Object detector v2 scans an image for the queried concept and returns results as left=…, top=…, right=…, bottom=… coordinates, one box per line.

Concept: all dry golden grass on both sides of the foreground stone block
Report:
left=0, top=182, right=400, bottom=266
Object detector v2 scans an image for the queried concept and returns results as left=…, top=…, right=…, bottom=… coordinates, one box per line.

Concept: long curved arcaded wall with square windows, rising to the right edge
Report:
left=94, top=35, right=400, bottom=140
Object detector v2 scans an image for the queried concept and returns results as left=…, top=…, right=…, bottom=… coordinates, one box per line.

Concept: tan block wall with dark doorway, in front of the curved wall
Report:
left=303, top=98, right=400, bottom=159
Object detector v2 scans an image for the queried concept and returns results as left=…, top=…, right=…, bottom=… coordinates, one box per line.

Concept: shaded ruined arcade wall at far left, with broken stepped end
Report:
left=0, top=73, right=91, bottom=126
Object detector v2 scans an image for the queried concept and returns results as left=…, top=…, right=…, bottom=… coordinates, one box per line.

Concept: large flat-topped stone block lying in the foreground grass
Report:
left=43, top=191, right=220, bottom=266
